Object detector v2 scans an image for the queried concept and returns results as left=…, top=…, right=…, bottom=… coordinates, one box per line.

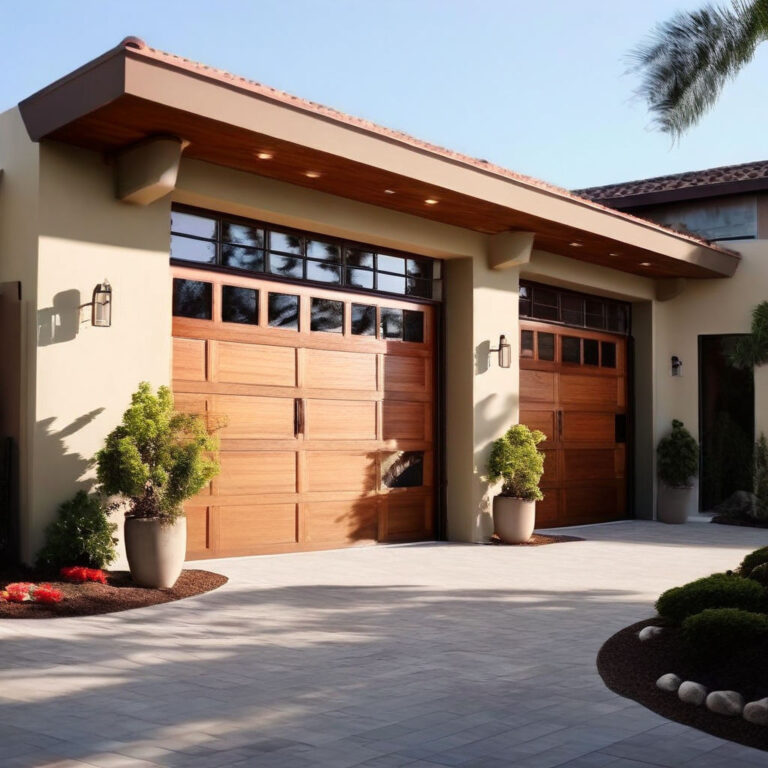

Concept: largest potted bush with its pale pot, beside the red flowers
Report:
left=96, top=382, right=219, bottom=589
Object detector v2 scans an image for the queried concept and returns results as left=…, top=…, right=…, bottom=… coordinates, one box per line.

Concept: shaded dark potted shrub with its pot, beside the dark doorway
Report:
left=656, top=419, right=699, bottom=524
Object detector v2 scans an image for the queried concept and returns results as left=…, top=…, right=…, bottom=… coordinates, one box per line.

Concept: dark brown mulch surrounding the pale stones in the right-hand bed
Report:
left=597, top=618, right=768, bottom=751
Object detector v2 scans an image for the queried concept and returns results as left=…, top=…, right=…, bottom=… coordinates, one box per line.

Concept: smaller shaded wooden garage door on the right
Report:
left=520, top=321, right=627, bottom=528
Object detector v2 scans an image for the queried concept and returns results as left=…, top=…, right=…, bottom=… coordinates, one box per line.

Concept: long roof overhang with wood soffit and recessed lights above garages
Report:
left=19, top=39, right=739, bottom=278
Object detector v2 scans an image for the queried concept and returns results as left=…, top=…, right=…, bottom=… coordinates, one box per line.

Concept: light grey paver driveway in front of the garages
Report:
left=0, top=522, right=768, bottom=768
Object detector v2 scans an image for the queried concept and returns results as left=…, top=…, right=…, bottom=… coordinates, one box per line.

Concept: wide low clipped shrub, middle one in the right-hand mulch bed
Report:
left=656, top=573, right=765, bottom=624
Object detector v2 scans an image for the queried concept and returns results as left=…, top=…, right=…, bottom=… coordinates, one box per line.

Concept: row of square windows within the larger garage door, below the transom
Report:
left=173, top=278, right=424, bottom=343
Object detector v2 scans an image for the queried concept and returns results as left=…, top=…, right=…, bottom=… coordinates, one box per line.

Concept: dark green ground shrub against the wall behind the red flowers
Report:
left=37, top=491, right=117, bottom=569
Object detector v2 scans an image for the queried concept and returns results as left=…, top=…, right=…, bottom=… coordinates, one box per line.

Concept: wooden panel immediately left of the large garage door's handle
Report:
left=211, top=395, right=295, bottom=440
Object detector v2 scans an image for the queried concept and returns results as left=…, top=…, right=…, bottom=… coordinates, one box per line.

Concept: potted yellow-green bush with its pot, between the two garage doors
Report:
left=488, top=424, right=547, bottom=544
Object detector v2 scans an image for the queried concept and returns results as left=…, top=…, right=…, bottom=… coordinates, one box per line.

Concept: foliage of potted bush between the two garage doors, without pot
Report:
left=488, top=424, right=547, bottom=501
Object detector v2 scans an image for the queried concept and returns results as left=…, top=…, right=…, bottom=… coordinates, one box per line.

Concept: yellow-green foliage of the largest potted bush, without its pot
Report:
left=96, top=381, right=219, bottom=521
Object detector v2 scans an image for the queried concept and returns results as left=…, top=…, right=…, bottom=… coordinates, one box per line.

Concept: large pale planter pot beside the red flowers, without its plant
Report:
left=125, top=516, right=187, bottom=589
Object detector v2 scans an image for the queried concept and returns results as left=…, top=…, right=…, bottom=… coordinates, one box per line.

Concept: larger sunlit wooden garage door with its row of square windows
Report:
left=172, top=267, right=435, bottom=559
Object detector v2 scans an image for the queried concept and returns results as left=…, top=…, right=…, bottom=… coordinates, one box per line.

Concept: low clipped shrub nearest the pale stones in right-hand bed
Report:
left=683, top=608, right=768, bottom=659
